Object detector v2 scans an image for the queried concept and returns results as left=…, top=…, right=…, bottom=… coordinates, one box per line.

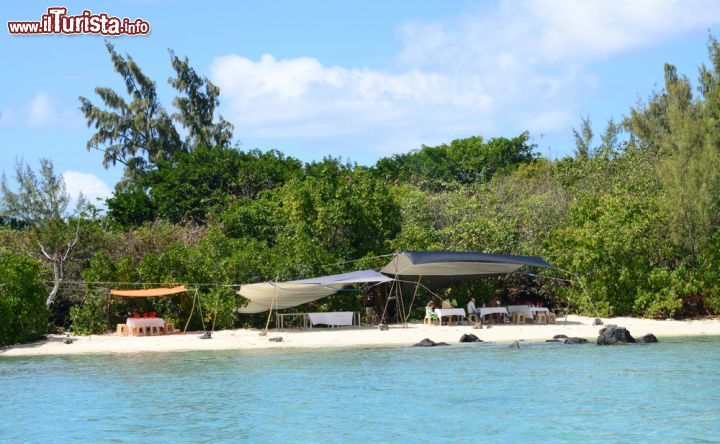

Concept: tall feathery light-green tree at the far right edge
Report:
left=627, top=65, right=720, bottom=258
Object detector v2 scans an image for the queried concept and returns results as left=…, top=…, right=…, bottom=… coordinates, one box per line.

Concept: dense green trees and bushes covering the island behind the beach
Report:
left=0, top=38, right=720, bottom=343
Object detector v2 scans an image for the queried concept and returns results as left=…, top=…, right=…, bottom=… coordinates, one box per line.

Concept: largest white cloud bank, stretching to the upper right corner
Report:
left=210, top=0, right=720, bottom=158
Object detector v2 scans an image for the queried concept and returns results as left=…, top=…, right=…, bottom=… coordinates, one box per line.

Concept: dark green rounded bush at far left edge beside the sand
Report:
left=0, top=249, right=50, bottom=345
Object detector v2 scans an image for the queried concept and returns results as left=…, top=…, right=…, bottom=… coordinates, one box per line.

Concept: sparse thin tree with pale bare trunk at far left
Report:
left=0, top=159, right=85, bottom=307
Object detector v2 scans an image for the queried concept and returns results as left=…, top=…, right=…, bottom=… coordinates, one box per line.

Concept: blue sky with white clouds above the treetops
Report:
left=0, top=0, right=720, bottom=206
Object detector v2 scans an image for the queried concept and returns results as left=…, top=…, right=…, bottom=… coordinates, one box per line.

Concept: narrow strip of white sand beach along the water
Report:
left=0, top=316, right=720, bottom=358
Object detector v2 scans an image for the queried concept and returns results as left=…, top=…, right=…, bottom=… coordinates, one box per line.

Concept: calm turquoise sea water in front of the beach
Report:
left=0, top=338, right=720, bottom=442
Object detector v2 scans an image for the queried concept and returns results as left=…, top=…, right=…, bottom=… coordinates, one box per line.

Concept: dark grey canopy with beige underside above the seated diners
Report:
left=380, top=251, right=555, bottom=282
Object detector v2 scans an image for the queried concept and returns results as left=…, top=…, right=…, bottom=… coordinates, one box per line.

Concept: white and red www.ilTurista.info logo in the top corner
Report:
left=7, top=6, right=150, bottom=36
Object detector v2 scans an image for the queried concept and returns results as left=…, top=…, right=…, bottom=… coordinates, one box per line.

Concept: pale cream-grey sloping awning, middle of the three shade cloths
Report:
left=238, top=270, right=393, bottom=314
